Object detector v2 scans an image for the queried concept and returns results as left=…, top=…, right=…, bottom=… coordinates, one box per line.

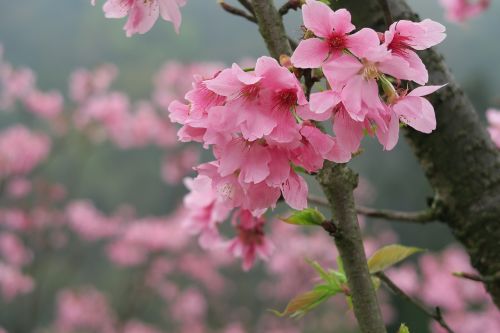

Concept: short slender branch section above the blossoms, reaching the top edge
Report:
left=253, top=0, right=292, bottom=59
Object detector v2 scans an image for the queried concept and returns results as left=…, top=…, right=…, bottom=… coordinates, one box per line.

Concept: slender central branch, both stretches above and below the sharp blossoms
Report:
left=253, top=0, right=386, bottom=333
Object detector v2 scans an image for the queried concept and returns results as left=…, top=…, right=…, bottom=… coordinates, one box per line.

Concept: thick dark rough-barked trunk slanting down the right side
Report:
left=332, top=0, right=500, bottom=307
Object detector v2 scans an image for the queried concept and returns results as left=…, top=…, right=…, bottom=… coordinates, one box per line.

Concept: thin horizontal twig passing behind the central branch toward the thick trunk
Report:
left=308, top=196, right=436, bottom=224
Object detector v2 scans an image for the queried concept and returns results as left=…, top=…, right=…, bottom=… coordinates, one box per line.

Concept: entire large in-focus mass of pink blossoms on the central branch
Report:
left=169, top=0, right=446, bottom=268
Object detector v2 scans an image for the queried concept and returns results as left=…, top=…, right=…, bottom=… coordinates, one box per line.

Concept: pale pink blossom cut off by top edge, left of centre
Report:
left=99, top=0, right=187, bottom=37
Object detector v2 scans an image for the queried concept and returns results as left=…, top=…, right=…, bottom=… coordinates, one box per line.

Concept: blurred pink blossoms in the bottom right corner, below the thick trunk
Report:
left=387, top=245, right=500, bottom=333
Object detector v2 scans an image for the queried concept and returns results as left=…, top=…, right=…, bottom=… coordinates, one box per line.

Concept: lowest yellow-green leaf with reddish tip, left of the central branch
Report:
left=271, top=285, right=332, bottom=317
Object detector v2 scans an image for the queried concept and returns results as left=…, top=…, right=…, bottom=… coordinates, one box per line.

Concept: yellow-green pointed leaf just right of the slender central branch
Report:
left=368, top=244, right=424, bottom=274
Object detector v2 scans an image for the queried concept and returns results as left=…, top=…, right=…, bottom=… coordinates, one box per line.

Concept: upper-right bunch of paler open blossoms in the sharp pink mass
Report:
left=291, top=0, right=446, bottom=152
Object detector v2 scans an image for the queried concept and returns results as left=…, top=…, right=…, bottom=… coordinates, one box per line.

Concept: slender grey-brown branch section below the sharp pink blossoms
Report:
left=316, top=162, right=386, bottom=333
